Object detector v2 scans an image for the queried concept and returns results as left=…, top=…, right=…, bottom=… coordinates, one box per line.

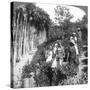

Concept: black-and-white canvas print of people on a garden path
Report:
left=10, top=2, right=88, bottom=88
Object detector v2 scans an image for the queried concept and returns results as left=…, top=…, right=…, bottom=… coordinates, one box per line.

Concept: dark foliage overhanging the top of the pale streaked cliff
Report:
left=14, top=3, right=50, bottom=30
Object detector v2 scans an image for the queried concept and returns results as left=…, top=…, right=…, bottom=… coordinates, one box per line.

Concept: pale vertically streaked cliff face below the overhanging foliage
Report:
left=13, top=26, right=46, bottom=86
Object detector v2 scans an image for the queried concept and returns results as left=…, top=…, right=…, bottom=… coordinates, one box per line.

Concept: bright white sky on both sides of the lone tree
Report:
left=36, top=3, right=86, bottom=22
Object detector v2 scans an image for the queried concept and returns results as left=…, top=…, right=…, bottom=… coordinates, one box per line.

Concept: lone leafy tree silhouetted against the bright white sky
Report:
left=55, top=5, right=73, bottom=28
